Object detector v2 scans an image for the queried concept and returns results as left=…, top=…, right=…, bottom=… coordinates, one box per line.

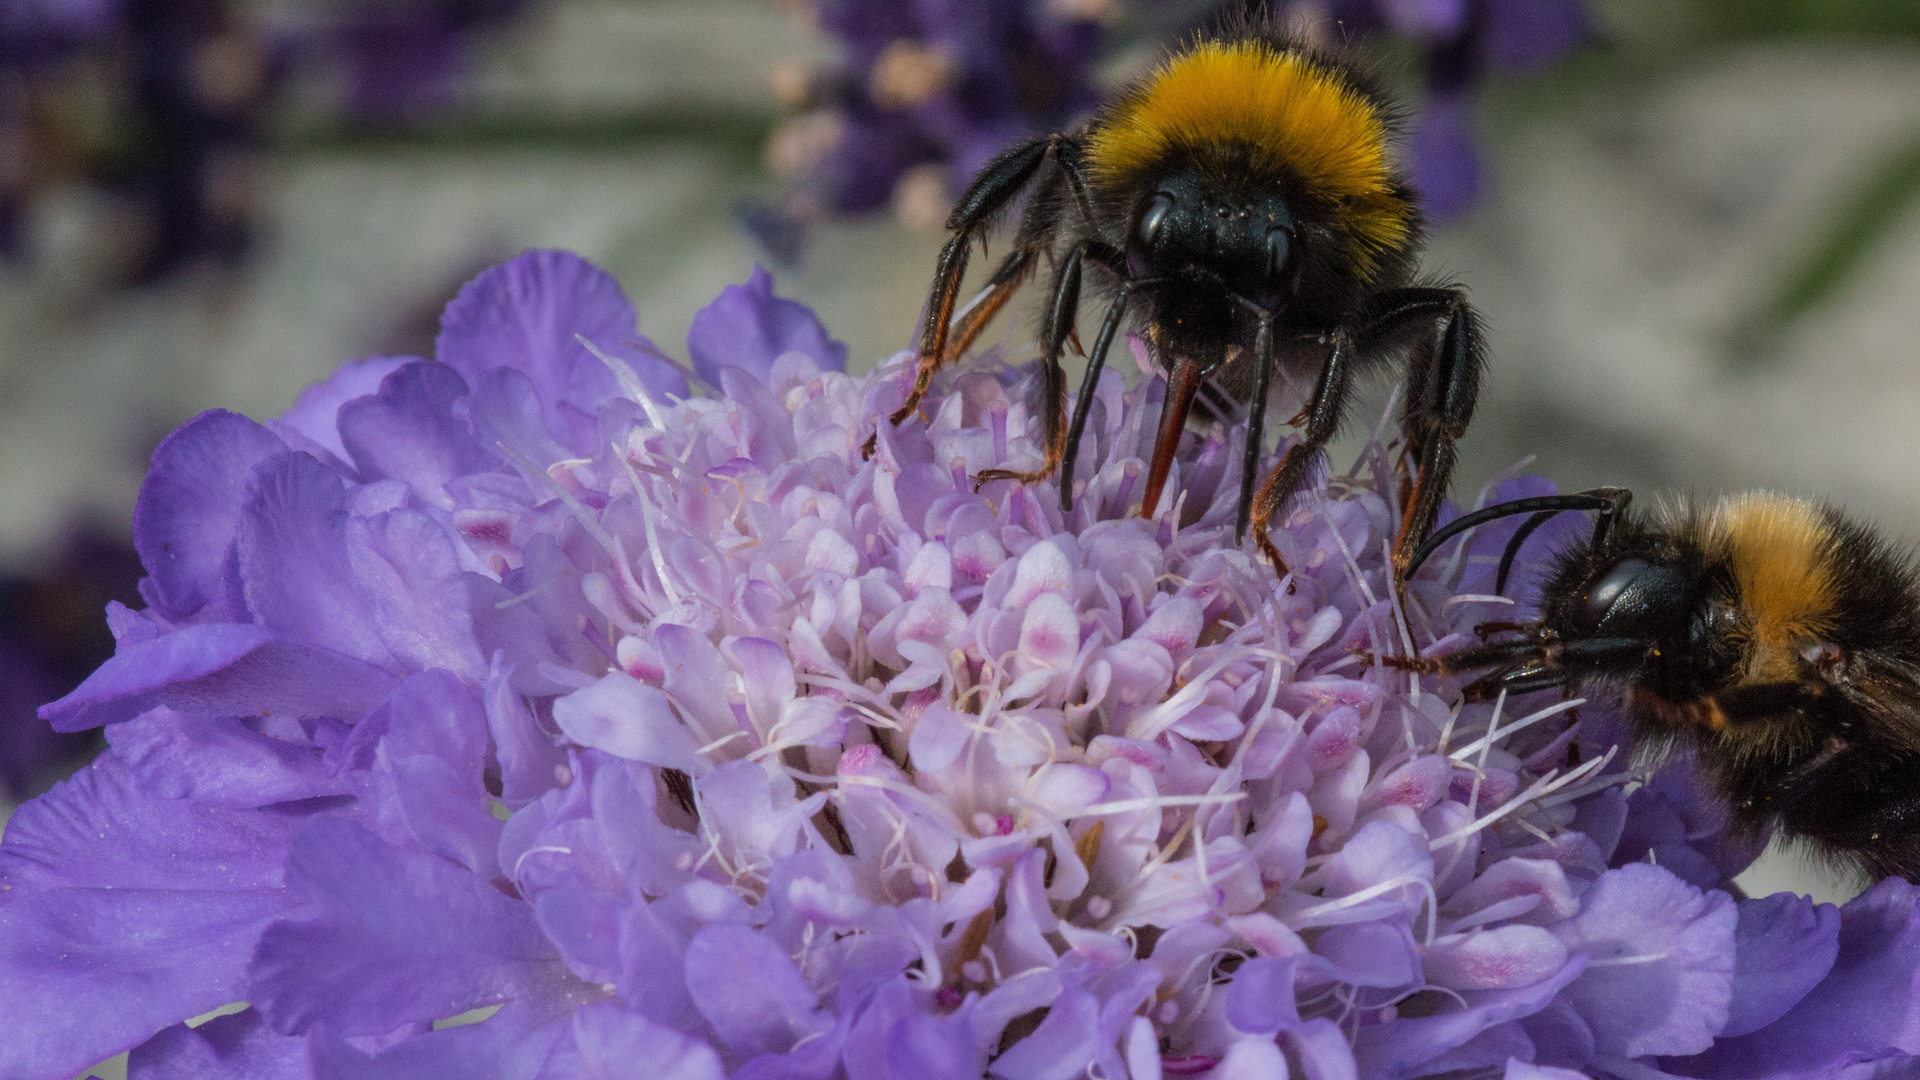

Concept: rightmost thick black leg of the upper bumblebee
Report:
left=1359, top=288, right=1486, bottom=582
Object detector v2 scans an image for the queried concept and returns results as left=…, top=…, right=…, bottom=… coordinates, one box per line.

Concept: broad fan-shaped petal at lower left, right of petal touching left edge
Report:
left=252, top=819, right=570, bottom=1034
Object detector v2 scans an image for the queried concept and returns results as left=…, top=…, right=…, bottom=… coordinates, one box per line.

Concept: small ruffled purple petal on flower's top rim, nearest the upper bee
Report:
left=687, top=265, right=847, bottom=386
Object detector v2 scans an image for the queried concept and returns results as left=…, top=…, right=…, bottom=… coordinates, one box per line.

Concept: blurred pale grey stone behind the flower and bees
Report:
left=0, top=12, right=1920, bottom=1060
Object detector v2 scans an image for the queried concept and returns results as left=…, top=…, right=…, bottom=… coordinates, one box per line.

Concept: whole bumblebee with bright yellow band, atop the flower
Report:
left=868, top=21, right=1484, bottom=567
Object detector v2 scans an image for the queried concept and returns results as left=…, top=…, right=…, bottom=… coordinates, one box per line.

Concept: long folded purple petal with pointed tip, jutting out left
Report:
left=40, top=623, right=397, bottom=732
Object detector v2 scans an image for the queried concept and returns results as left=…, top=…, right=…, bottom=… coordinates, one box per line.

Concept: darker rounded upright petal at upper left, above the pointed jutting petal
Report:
left=132, top=409, right=286, bottom=619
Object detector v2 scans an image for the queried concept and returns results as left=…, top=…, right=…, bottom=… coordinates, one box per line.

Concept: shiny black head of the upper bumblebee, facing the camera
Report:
left=1127, top=169, right=1300, bottom=304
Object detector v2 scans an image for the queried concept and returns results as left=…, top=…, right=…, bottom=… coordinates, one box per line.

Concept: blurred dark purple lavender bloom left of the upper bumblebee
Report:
left=743, top=0, right=1116, bottom=259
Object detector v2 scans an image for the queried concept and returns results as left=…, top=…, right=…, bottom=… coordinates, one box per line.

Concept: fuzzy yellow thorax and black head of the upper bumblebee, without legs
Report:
left=1087, top=35, right=1419, bottom=290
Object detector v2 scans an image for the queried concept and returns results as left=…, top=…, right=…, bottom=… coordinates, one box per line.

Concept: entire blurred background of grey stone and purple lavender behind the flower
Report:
left=0, top=0, right=1920, bottom=926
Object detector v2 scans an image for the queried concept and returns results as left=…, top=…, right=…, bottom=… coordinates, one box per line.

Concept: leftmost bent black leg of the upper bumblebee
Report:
left=862, top=135, right=1087, bottom=457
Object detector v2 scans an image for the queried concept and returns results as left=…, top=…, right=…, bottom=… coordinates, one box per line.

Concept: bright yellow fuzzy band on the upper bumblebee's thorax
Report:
left=1087, top=40, right=1413, bottom=277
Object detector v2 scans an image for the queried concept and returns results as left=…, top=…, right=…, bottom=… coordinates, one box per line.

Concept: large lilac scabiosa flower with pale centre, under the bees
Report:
left=0, top=252, right=1920, bottom=1080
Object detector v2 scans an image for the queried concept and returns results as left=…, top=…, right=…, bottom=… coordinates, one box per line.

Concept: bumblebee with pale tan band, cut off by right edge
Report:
left=1398, top=488, right=1920, bottom=878
